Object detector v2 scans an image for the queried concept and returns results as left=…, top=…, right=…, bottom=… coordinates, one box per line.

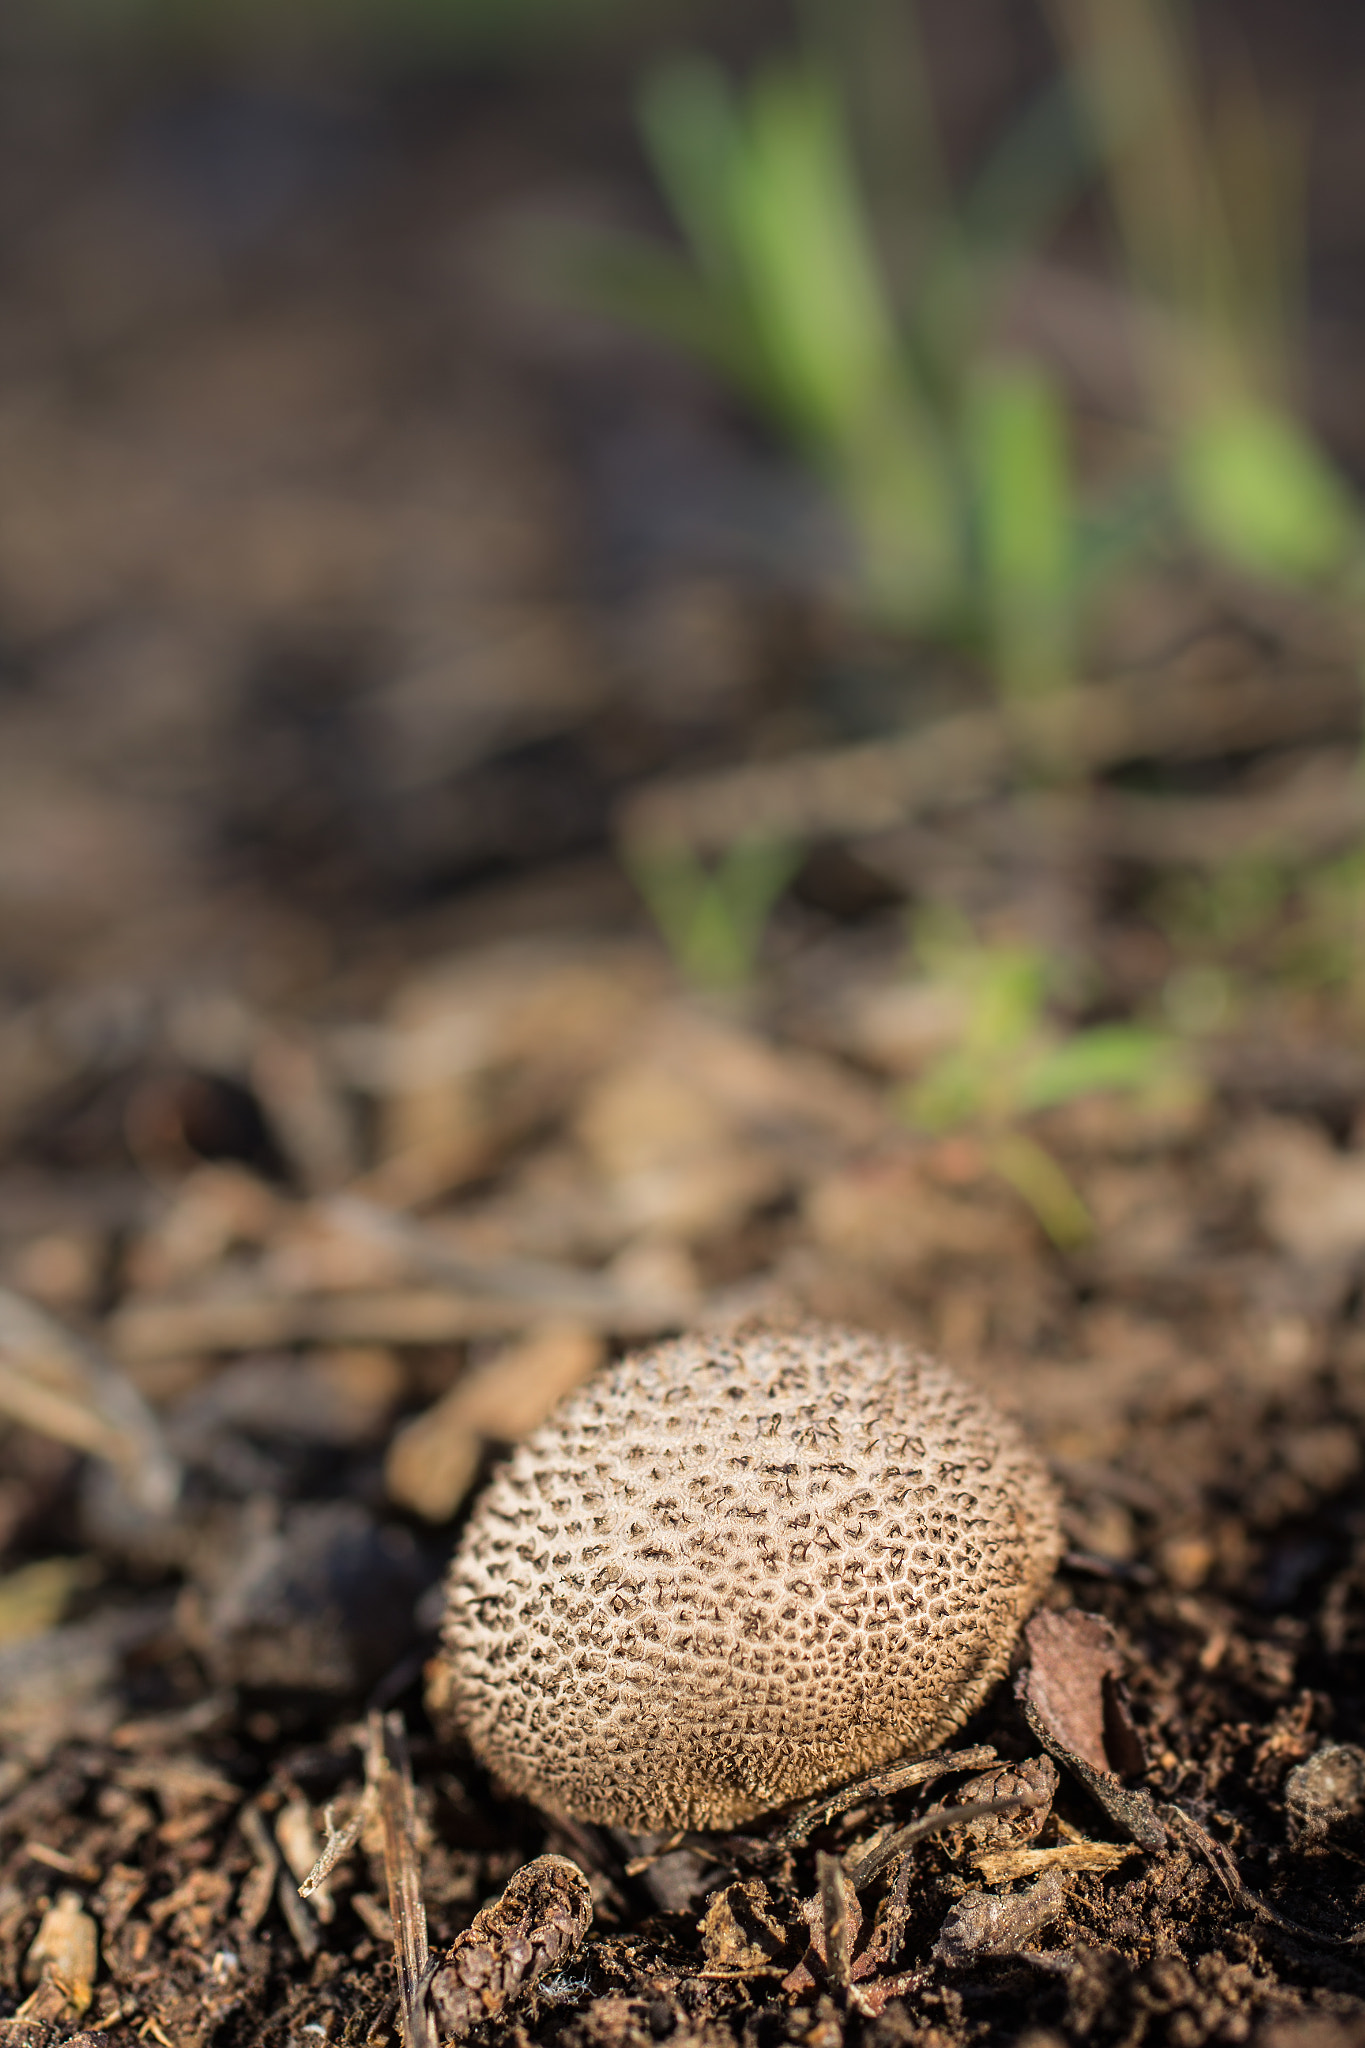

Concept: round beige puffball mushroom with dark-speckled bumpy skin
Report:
left=430, top=1323, right=1060, bottom=1831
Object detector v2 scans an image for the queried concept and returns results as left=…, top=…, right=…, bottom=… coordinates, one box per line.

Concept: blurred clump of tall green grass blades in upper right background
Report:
left=564, top=0, right=1363, bottom=700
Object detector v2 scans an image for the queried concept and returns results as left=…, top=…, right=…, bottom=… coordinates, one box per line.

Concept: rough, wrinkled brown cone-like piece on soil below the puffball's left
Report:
left=422, top=1855, right=591, bottom=2042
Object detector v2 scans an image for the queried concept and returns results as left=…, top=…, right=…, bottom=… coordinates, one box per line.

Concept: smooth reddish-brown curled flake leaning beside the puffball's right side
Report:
left=1015, top=1608, right=1166, bottom=1849
